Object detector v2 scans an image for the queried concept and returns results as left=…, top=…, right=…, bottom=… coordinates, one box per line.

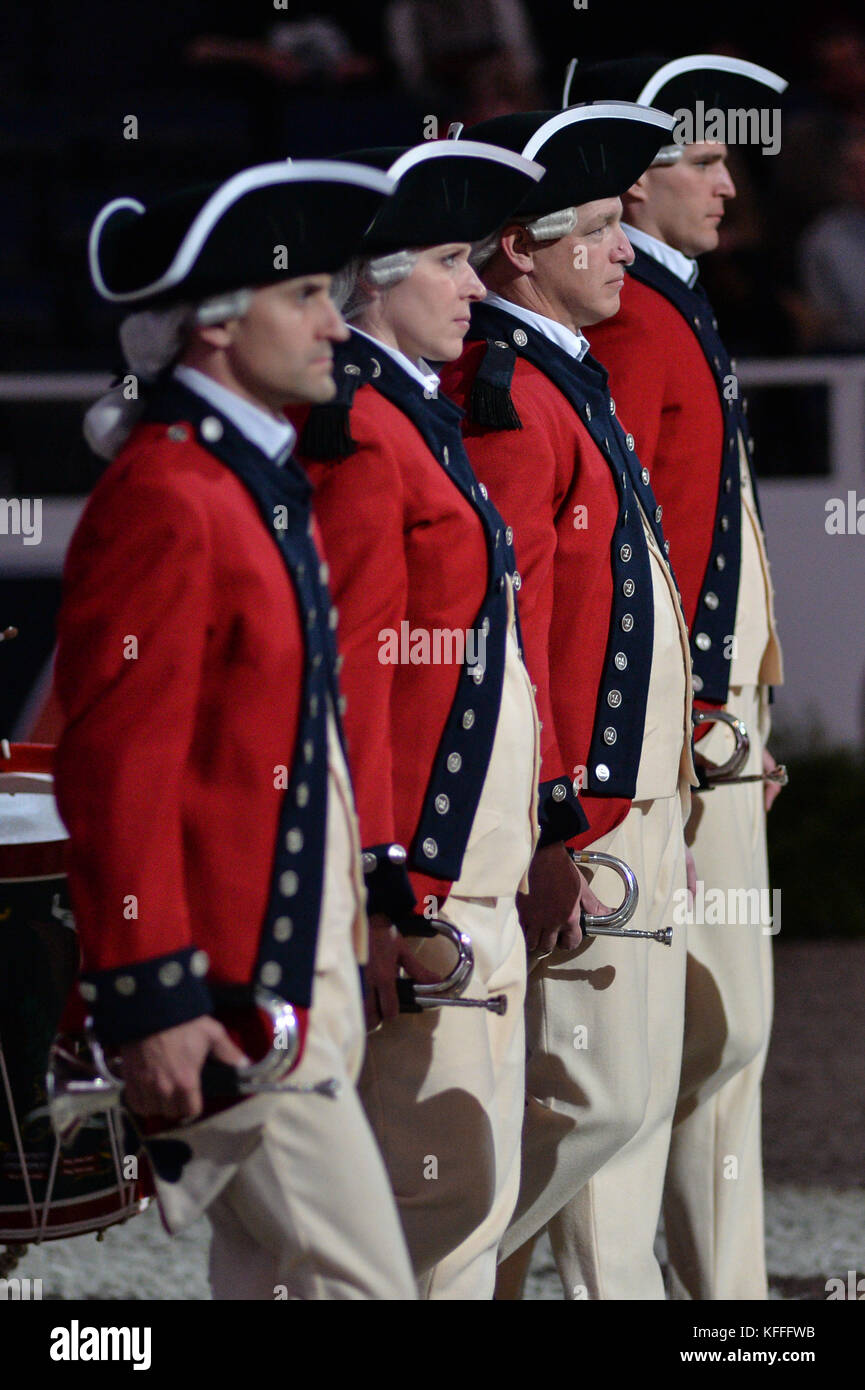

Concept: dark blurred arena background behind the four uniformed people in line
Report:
left=0, top=0, right=865, bottom=1322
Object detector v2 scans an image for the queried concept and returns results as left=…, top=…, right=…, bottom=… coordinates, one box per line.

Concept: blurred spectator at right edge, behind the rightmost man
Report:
left=798, top=122, right=865, bottom=352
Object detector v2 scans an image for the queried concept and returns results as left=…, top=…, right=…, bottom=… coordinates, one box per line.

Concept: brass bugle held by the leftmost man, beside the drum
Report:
left=44, top=986, right=339, bottom=1144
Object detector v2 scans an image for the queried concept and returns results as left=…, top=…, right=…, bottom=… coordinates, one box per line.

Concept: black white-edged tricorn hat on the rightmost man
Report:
left=562, top=53, right=787, bottom=115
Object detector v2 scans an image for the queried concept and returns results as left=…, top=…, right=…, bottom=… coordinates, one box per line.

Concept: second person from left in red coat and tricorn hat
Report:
left=292, top=142, right=603, bottom=1300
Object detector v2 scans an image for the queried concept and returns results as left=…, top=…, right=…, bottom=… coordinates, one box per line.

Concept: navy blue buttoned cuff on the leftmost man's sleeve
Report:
left=78, top=947, right=213, bottom=1045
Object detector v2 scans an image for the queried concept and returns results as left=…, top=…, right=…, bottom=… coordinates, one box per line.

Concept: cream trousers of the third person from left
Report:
left=501, top=795, right=686, bottom=1298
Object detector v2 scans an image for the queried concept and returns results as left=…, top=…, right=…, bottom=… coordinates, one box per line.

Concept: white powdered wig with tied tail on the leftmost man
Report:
left=83, top=289, right=253, bottom=459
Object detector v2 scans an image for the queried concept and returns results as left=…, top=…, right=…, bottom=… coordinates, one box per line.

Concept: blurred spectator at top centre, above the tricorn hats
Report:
left=385, top=0, right=544, bottom=122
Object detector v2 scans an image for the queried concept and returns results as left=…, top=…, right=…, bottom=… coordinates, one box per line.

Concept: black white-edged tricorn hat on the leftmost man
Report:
left=89, top=160, right=395, bottom=307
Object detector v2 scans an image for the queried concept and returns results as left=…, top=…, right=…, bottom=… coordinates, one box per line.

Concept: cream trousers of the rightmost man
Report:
left=663, top=685, right=780, bottom=1300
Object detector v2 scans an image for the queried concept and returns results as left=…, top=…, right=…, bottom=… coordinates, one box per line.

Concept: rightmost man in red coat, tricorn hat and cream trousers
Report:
left=570, top=54, right=786, bottom=1298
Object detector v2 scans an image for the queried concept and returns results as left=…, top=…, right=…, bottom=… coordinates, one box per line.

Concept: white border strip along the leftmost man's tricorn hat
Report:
left=88, top=160, right=396, bottom=303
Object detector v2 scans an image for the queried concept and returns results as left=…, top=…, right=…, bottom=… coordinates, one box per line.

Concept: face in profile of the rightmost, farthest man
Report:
left=634, top=142, right=736, bottom=257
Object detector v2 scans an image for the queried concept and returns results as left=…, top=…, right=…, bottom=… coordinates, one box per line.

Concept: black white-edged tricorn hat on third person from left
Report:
left=451, top=101, right=676, bottom=225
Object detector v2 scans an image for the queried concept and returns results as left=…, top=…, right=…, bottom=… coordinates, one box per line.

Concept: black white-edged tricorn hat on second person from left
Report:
left=342, top=140, right=544, bottom=256
